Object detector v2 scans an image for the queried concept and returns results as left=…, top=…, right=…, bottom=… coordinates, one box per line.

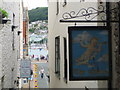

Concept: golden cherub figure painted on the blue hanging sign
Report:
left=76, top=37, right=102, bottom=65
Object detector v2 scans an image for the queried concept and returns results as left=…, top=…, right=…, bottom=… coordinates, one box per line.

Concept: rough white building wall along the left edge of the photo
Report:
left=0, top=0, right=23, bottom=89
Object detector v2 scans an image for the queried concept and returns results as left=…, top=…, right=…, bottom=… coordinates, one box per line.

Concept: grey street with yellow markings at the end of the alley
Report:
left=32, top=61, right=49, bottom=88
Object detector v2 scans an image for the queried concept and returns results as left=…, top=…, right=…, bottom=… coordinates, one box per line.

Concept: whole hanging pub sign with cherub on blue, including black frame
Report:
left=68, top=26, right=111, bottom=80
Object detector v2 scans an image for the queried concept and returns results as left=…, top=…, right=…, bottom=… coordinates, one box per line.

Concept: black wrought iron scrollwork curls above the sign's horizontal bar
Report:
left=62, top=5, right=106, bottom=21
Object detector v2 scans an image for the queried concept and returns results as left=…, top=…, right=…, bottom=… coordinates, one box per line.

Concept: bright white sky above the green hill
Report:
left=23, top=0, right=48, bottom=10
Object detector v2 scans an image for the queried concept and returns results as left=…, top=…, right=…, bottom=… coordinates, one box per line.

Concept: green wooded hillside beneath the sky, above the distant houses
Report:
left=28, top=7, right=48, bottom=22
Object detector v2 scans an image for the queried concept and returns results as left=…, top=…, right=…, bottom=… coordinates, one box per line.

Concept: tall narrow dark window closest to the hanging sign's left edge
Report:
left=63, top=38, right=67, bottom=83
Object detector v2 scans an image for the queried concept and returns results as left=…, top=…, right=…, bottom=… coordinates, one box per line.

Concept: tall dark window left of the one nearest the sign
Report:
left=55, top=36, right=60, bottom=78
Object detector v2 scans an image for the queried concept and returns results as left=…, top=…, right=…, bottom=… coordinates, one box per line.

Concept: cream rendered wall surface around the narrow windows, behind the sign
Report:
left=48, top=0, right=107, bottom=88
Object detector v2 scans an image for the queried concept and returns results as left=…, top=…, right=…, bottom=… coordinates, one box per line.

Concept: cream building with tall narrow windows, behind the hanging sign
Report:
left=48, top=0, right=119, bottom=88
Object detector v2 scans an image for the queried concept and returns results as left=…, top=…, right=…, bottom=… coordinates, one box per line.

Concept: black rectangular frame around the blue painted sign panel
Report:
left=68, top=26, right=112, bottom=81
